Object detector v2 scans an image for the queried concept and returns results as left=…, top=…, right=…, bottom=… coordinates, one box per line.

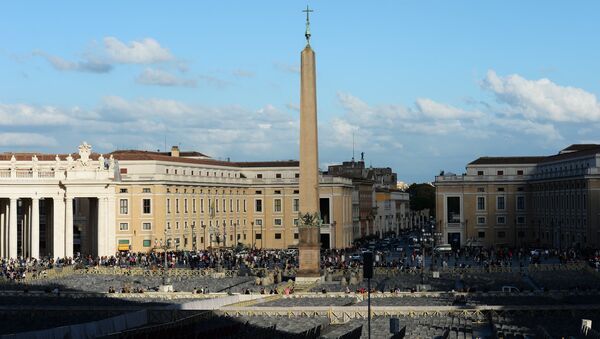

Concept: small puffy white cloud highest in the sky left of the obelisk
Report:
left=104, top=37, right=174, bottom=64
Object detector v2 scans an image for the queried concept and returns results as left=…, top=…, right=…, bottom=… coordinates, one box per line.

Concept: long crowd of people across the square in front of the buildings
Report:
left=0, top=247, right=600, bottom=281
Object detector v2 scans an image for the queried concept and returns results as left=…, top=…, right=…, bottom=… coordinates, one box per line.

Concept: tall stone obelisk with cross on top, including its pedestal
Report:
left=296, top=6, right=321, bottom=283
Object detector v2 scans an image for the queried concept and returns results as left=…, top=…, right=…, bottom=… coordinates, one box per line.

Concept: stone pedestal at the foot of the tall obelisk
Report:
left=296, top=227, right=321, bottom=284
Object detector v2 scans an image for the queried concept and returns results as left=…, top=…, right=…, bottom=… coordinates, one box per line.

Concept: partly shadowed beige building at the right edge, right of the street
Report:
left=435, top=145, right=600, bottom=248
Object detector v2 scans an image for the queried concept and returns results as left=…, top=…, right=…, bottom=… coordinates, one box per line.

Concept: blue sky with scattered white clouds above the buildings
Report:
left=0, top=0, right=600, bottom=182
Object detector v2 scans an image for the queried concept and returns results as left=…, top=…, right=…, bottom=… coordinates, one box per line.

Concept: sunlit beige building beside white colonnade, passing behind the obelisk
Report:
left=113, top=148, right=353, bottom=251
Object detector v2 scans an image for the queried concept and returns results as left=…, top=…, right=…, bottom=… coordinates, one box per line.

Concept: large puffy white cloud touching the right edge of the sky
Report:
left=481, top=70, right=600, bottom=122
